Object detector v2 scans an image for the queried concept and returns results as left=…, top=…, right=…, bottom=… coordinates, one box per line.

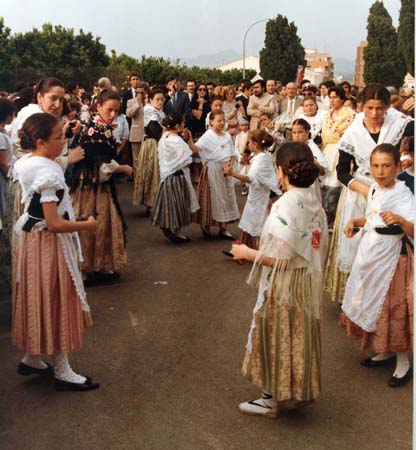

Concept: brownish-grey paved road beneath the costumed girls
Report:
left=0, top=184, right=412, bottom=450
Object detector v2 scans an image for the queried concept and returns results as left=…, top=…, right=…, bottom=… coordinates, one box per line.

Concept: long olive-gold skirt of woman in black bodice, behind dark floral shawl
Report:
left=133, top=139, right=160, bottom=208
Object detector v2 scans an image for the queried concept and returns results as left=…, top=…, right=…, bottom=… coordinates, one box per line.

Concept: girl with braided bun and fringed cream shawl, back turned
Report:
left=232, top=142, right=327, bottom=418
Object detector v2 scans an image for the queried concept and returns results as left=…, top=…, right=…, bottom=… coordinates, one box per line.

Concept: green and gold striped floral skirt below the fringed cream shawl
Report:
left=242, top=268, right=321, bottom=401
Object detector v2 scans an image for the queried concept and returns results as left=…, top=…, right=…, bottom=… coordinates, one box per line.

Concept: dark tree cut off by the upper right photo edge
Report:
left=397, top=0, right=415, bottom=75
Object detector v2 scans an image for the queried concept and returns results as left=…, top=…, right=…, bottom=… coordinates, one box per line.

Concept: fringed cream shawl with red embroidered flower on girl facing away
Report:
left=247, top=186, right=328, bottom=350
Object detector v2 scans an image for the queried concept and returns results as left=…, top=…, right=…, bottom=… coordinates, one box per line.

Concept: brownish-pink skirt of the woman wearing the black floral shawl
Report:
left=71, top=183, right=127, bottom=272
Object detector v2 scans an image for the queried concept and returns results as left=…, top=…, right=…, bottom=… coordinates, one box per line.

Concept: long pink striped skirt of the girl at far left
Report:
left=12, top=228, right=92, bottom=355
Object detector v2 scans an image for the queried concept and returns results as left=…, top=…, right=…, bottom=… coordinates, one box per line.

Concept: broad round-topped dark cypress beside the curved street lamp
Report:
left=260, top=14, right=305, bottom=83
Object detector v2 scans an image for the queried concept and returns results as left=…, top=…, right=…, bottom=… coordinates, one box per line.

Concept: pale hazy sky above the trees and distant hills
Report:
left=0, top=0, right=400, bottom=62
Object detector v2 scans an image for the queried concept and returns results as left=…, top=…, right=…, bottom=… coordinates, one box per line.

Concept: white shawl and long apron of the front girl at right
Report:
left=342, top=181, right=414, bottom=332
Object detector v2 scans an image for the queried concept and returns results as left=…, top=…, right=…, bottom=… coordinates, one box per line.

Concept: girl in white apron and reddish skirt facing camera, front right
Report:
left=340, top=144, right=414, bottom=387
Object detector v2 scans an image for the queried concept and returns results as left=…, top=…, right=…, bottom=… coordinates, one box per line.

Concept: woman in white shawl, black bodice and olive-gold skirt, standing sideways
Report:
left=133, top=89, right=165, bottom=217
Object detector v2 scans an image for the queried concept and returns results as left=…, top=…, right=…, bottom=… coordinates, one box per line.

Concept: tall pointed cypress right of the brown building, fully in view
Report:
left=364, top=1, right=406, bottom=87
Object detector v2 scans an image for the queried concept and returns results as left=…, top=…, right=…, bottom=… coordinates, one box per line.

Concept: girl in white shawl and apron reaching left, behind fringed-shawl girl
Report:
left=224, top=130, right=280, bottom=251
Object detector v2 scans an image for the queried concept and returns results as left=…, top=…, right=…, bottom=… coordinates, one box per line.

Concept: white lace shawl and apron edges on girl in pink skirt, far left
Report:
left=15, top=153, right=90, bottom=311
